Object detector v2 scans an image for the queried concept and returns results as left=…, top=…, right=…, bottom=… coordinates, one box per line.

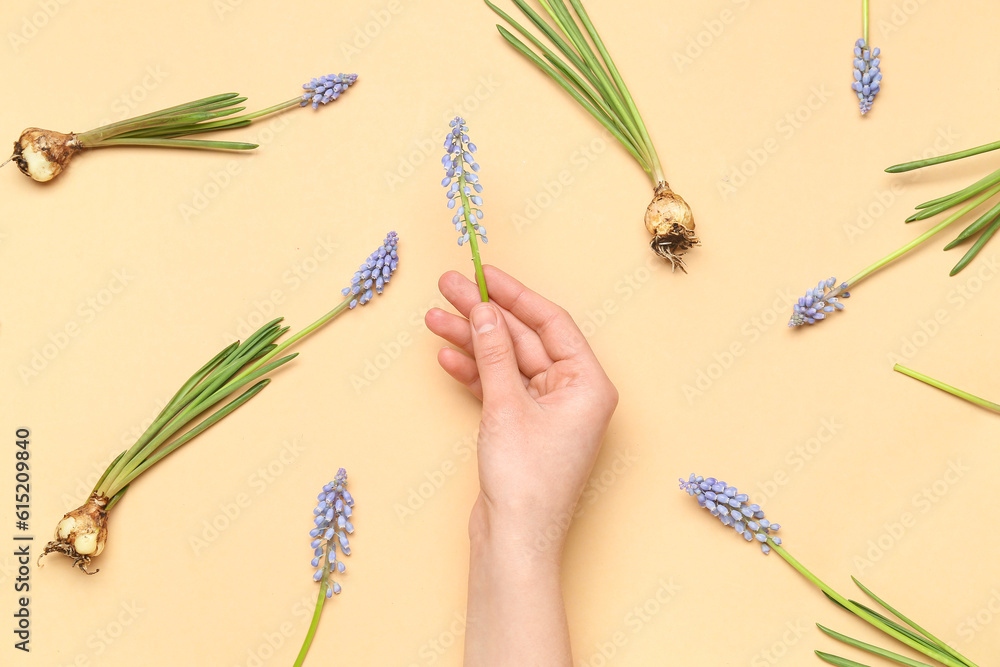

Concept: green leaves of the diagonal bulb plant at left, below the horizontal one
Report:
left=94, top=318, right=298, bottom=509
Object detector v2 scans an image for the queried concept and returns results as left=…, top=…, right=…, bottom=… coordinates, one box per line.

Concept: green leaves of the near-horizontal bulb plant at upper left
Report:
left=78, top=93, right=258, bottom=150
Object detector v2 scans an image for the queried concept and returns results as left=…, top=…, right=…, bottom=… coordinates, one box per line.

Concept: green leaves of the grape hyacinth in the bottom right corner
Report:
left=816, top=577, right=976, bottom=667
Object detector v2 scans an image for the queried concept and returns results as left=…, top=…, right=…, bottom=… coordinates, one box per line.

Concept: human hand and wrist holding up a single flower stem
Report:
left=426, top=267, right=618, bottom=665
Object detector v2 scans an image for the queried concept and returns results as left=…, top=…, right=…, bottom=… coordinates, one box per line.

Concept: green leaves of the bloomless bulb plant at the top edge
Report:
left=485, top=0, right=663, bottom=184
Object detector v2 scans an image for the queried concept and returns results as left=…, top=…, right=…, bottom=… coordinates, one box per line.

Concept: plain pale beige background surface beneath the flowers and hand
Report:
left=0, top=0, right=1000, bottom=667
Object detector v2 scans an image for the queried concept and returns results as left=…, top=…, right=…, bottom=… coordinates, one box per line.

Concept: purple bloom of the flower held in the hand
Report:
left=441, top=116, right=489, bottom=245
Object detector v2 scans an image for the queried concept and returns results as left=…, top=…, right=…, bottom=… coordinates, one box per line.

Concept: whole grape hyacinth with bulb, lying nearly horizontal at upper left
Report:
left=0, top=74, right=358, bottom=183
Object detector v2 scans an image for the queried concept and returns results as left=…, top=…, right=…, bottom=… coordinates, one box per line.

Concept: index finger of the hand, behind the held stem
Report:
left=483, top=266, right=594, bottom=361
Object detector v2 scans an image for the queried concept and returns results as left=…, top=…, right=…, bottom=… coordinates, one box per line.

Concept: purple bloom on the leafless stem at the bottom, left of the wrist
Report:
left=309, top=468, right=354, bottom=598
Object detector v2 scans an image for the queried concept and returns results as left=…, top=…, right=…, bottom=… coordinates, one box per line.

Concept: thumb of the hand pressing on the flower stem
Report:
left=469, top=302, right=524, bottom=404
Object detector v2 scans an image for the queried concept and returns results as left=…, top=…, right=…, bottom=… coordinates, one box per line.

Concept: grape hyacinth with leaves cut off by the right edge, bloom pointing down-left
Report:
left=788, top=141, right=1000, bottom=327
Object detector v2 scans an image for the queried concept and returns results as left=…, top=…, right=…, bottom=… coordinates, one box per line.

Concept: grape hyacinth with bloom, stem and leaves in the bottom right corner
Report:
left=679, top=474, right=977, bottom=667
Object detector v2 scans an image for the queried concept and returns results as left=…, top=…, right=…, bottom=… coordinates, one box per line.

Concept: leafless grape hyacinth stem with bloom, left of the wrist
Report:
left=294, top=468, right=354, bottom=667
